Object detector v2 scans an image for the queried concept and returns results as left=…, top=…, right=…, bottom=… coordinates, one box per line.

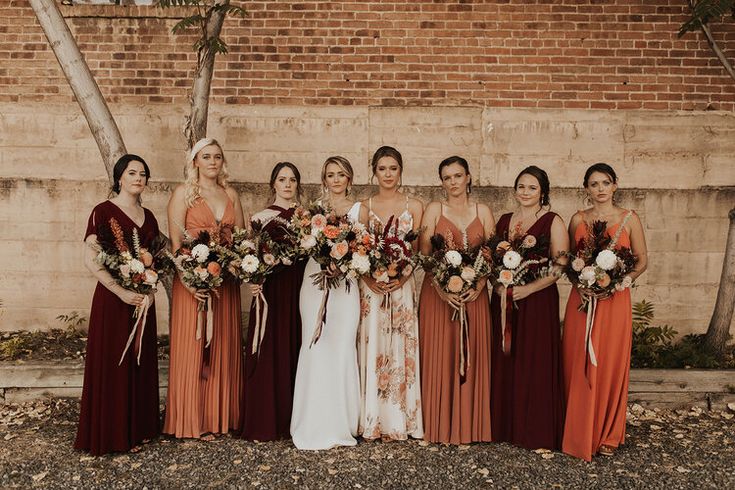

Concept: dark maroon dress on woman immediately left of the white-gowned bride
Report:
left=240, top=205, right=308, bottom=441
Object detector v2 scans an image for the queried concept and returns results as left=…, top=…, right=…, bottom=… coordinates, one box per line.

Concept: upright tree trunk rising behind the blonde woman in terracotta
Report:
left=184, top=0, right=229, bottom=148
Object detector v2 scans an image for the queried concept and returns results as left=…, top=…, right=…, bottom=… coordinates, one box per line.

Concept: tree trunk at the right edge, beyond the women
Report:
left=704, top=208, right=735, bottom=358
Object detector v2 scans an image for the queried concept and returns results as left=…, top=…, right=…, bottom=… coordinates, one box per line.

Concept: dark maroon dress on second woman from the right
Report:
left=490, top=212, right=564, bottom=449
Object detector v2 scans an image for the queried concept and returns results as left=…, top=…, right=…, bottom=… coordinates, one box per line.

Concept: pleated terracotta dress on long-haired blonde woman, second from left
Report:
left=163, top=198, right=242, bottom=438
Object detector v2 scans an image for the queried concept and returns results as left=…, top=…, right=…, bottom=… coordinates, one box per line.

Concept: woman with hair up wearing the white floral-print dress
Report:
left=358, top=146, right=423, bottom=440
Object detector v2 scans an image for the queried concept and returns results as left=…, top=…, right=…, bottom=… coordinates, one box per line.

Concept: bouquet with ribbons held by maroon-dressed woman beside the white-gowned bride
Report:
left=219, top=221, right=293, bottom=354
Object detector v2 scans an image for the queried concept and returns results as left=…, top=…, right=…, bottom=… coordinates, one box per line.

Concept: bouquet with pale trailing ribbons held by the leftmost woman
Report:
left=95, top=218, right=171, bottom=365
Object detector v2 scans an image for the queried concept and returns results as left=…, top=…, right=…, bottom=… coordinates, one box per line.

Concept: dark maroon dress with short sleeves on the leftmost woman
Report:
left=74, top=201, right=160, bottom=455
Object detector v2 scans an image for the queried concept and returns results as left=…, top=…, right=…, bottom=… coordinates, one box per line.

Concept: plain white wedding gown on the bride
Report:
left=291, top=203, right=360, bottom=449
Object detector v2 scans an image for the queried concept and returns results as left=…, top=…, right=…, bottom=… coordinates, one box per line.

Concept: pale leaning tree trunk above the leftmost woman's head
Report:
left=30, top=0, right=127, bottom=183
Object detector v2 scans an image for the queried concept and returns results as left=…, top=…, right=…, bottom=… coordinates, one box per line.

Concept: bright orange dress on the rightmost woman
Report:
left=562, top=218, right=633, bottom=461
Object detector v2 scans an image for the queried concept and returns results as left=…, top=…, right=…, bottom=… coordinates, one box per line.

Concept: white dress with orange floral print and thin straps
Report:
left=358, top=198, right=424, bottom=440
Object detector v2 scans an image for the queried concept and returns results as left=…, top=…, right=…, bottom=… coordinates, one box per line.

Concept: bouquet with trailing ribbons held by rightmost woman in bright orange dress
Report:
left=564, top=211, right=638, bottom=372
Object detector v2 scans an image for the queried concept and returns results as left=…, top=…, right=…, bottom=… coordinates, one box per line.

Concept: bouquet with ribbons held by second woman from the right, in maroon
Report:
left=485, top=227, right=552, bottom=354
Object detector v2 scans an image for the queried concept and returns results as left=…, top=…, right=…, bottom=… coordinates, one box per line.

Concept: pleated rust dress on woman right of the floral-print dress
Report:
left=419, top=206, right=491, bottom=444
